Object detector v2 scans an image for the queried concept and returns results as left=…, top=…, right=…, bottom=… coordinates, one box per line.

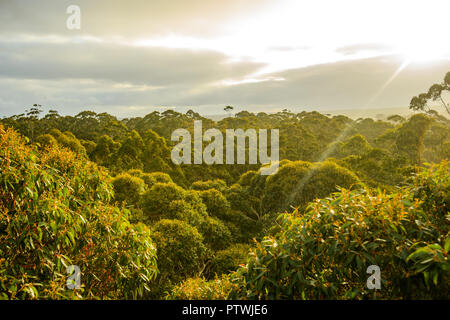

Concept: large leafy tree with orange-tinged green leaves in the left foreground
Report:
left=0, top=125, right=157, bottom=299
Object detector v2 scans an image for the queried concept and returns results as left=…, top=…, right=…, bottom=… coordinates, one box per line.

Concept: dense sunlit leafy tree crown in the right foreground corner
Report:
left=230, top=163, right=450, bottom=299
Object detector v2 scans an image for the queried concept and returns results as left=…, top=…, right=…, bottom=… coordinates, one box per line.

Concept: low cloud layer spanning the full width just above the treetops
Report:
left=0, top=53, right=450, bottom=117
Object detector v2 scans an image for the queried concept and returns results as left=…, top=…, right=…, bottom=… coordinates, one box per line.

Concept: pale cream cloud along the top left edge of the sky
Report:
left=0, top=0, right=270, bottom=37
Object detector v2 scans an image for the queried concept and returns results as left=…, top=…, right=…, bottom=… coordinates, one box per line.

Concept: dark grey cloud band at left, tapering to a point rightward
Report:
left=0, top=42, right=263, bottom=86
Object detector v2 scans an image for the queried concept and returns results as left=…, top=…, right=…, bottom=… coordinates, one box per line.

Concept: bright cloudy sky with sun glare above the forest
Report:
left=0, top=0, right=450, bottom=117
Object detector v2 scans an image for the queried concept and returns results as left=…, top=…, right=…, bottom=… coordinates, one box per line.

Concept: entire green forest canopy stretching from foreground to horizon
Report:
left=0, top=105, right=450, bottom=299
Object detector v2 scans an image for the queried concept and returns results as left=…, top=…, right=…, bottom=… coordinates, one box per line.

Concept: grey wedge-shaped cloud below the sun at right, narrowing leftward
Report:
left=178, top=56, right=450, bottom=110
